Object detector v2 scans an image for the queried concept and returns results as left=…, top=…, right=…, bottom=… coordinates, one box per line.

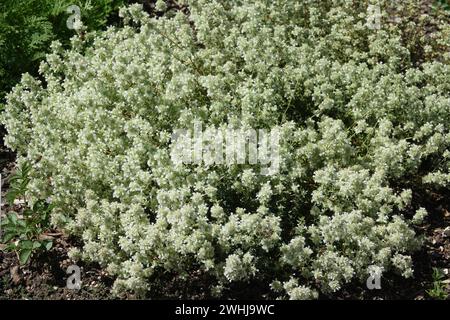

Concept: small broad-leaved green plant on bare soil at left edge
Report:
left=1, top=163, right=53, bottom=264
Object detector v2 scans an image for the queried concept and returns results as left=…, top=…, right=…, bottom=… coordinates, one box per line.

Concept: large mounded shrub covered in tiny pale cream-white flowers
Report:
left=2, top=0, right=450, bottom=298
